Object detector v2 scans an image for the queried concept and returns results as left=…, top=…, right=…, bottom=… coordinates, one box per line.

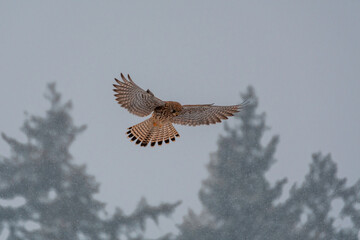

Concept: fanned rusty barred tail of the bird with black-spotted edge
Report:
left=126, top=118, right=180, bottom=147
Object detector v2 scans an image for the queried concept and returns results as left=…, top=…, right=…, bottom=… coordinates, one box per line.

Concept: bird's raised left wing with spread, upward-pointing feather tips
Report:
left=113, top=74, right=165, bottom=117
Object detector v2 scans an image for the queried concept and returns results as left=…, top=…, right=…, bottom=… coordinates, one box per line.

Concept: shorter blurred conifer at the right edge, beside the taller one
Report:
left=288, top=153, right=360, bottom=240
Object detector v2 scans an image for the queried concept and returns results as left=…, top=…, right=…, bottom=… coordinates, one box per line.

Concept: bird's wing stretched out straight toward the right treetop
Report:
left=172, top=104, right=243, bottom=126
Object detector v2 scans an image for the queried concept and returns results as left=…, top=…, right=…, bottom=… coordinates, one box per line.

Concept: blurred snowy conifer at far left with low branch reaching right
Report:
left=0, top=84, right=179, bottom=240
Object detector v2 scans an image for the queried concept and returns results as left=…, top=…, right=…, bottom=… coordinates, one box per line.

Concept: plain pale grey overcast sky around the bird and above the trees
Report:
left=0, top=0, right=360, bottom=236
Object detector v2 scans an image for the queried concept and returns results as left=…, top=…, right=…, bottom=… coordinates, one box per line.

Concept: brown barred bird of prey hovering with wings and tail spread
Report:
left=113, top=73, right=246, bottom=147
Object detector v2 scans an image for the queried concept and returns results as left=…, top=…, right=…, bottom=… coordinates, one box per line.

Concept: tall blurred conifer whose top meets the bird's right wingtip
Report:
left=179, top=88, right=294, bottom=240
